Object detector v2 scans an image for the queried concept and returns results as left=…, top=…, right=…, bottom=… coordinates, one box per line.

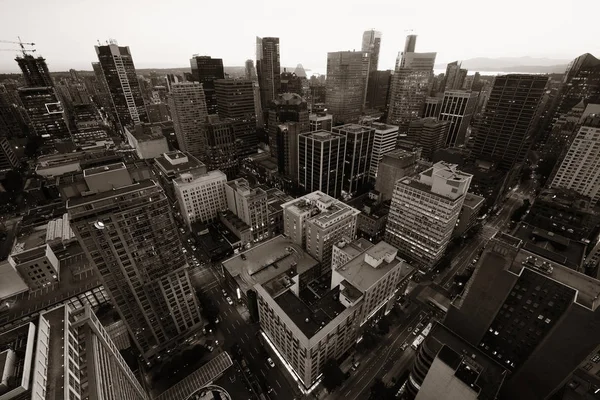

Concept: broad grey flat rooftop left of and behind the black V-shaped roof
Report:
left=223, top=235, right=318, bottom=293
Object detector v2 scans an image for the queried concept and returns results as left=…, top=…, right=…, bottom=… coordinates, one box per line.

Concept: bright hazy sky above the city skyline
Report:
left=0, top=0, right=600, bottom=72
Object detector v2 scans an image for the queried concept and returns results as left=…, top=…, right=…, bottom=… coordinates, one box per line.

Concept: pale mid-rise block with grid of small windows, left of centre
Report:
left=173, top=170, right=227, bottom=227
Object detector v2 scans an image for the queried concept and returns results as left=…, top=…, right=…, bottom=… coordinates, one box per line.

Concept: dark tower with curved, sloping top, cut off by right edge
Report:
left=556, top=53, right=600, bottom=117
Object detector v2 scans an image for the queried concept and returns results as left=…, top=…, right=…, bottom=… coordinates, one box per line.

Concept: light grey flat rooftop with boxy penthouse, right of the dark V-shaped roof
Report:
left=336, top=242, right=413, bottom=293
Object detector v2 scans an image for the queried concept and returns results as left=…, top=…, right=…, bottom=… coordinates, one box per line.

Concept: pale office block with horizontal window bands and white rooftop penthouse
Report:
left=385, top=161, right=472, bottom=269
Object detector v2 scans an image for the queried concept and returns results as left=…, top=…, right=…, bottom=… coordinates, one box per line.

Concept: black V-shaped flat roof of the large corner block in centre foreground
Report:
left=274, top=287, right=346, bottom=339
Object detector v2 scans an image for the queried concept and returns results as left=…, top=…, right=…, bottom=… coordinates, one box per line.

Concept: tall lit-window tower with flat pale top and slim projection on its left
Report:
left=387, top=35, right=436, bottom=133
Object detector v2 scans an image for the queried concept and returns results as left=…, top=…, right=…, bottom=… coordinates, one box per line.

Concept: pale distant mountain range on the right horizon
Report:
left=435, top=57, right=571, bottom=74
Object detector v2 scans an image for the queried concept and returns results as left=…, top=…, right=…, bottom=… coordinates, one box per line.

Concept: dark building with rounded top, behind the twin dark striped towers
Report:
left=264, top=93, right=309, bottom=158
